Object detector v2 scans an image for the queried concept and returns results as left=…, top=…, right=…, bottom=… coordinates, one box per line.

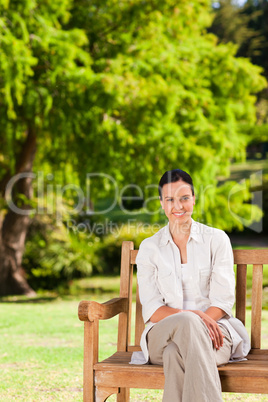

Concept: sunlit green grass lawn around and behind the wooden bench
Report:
left=0, top=278, right=268, bottom=402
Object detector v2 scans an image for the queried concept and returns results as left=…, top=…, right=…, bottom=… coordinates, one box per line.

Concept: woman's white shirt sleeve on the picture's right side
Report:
left=209, top=231, right=235, bottom=316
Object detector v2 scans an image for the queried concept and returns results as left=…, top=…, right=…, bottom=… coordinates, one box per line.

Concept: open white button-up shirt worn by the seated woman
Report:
left=131, top=219, right=250, bottom=364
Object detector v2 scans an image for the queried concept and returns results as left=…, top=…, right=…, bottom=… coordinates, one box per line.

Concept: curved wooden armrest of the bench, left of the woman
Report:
left=78, top=297, right=128, bottom=322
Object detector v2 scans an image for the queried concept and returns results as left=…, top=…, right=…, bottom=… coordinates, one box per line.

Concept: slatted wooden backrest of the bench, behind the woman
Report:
left=118, top=241, right=268, bottom=351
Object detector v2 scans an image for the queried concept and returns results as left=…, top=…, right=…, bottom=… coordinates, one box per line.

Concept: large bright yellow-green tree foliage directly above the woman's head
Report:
left=66, top=1, right=265, bottom=228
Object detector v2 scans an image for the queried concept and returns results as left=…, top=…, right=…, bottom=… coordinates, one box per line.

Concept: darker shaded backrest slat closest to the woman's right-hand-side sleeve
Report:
left=235, top=264, right=247, bottom=325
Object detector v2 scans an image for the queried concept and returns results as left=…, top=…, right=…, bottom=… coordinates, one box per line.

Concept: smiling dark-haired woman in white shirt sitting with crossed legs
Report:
left=132, top=169, right=250, bottom=402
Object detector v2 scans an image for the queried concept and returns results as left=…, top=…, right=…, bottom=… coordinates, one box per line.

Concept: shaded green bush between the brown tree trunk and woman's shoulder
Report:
left=23, top=216, right=163, bottom=290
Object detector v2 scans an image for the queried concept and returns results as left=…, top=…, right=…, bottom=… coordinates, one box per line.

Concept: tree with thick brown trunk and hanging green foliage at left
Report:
left=0, top=0, right=94, bottom=295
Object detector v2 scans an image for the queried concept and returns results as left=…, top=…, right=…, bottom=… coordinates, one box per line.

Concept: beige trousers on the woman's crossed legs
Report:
left=147, top=312, right=232, bottom=402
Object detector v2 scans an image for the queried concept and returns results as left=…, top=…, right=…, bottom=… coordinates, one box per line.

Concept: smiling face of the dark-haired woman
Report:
left=160, top=180, right=195, bottom=225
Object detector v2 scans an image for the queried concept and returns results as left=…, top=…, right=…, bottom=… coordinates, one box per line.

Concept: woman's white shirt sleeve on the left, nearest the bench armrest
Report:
left=136, top=239, right=165, bottom=324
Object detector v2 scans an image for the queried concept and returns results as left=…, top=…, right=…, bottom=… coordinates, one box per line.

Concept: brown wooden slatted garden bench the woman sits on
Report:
left=78, top=241, right=268, bottom=402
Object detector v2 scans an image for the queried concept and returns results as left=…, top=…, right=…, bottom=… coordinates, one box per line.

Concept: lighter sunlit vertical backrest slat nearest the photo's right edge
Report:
left=251, top=265, right=263, bottom=349
